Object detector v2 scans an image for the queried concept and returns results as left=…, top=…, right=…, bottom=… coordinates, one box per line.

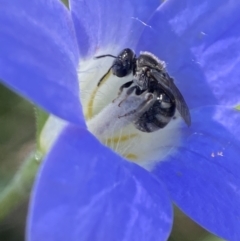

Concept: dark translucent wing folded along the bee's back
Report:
left=151, top=70, right=191, bottom=126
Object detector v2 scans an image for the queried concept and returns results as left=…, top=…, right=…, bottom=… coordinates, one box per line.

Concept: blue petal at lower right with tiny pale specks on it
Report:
left=154, top=106, right=240, bottom=241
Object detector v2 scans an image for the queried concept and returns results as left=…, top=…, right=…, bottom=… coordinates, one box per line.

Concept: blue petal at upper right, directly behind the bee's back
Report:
left=137, top=0, right=240, bottom=108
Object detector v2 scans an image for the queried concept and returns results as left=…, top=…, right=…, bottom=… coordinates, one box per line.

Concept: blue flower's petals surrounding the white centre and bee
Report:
left=0, top=0, right=240, bottom=241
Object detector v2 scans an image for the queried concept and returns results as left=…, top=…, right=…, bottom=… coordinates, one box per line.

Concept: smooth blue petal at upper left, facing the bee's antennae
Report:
left=0, top=0, right=83, bottom=124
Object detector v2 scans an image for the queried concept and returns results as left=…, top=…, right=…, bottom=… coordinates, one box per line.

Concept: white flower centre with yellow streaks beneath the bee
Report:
left=78, top=49, right=183, bottom=170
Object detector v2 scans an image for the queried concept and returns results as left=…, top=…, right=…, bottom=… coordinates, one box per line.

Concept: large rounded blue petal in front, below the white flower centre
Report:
left=28, top=127, right=172, bottom=241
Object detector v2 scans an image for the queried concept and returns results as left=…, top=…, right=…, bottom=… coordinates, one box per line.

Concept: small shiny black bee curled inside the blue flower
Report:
left=96, top=48, right=191, bottom=132
